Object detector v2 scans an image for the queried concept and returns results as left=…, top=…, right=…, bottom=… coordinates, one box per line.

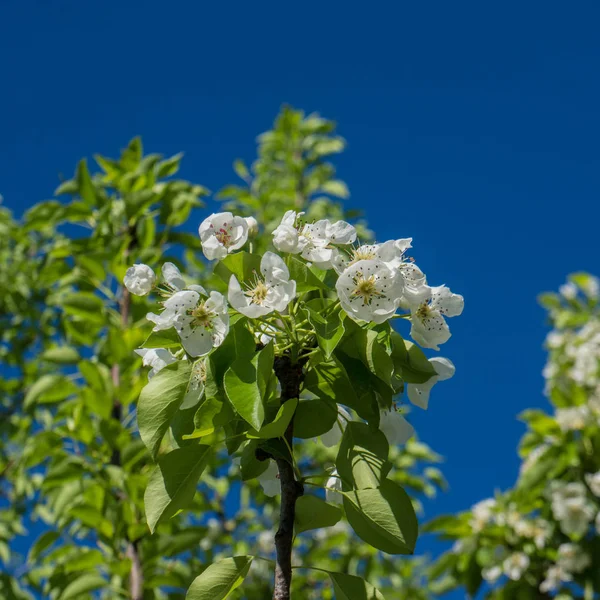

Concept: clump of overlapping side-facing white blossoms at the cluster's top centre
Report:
left=273, top=210, right=356, bottom=269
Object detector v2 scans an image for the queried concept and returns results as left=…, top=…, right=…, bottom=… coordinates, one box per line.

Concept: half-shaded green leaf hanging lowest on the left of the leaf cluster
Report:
left=144, top=444, right=211, bottom=533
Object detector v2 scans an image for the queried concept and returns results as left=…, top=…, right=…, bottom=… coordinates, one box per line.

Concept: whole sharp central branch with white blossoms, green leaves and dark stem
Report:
left=124, top=205, right=463, bottom=600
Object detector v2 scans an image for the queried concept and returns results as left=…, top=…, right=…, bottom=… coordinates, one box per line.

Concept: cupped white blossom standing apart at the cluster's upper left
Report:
left=198, top=212, right=248, bottom=260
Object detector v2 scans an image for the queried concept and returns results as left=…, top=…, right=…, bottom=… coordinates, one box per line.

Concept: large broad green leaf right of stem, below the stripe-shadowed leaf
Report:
left=342, top=479, right=418, bottom=554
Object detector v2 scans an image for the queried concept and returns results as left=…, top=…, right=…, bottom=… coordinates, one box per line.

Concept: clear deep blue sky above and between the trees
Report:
left=0, top=0, right=600, bottom=596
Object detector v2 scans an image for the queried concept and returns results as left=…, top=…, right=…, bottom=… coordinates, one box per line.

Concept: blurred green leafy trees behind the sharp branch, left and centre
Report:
left=0, top=108, right=444, bottom=600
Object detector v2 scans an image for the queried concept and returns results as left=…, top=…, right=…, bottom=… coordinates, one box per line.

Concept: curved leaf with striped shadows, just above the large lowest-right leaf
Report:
left=335, top=421, right=391, bottom=490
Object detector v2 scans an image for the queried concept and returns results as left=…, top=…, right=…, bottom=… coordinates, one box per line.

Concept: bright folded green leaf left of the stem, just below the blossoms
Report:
left=223, top=344, right=273, bottom=430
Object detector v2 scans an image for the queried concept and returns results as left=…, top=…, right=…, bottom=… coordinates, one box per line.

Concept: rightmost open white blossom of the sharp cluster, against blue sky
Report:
left=410, top=285, right=465, bottom=350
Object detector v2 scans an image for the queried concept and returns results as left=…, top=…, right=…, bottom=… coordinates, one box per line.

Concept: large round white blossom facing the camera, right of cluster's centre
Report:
left=335, top=260, right=402, bottom=323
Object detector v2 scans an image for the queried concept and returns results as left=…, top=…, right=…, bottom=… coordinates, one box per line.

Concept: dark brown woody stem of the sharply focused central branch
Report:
left=273, top=356, right=304, bottom=600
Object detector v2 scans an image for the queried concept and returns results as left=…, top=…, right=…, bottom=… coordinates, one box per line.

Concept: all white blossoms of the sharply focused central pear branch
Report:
left=123, top=210, right=464, bottom=474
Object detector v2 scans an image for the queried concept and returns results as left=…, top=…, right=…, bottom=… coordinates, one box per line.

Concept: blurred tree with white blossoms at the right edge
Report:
left=430, top=273, right=600, bottom=600
